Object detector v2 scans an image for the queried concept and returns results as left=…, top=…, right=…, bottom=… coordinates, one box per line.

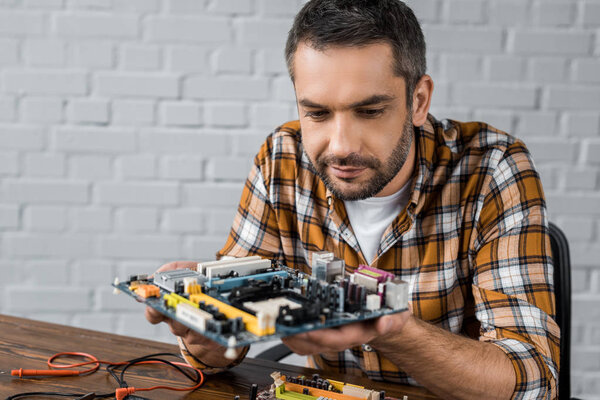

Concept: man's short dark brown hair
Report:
left=285, top=0, right=427, bottom=105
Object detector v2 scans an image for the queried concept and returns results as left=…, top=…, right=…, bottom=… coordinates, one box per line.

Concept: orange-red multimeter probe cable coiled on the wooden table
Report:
left=11, top=352, right=204, bottom=400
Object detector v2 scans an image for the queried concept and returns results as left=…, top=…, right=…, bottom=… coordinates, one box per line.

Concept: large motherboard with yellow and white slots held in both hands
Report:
left=113, top=252, right=408, bottom=356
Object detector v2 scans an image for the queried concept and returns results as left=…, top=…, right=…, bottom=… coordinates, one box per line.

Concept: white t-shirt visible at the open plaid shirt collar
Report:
left=344, top=181, right=411, bottom=264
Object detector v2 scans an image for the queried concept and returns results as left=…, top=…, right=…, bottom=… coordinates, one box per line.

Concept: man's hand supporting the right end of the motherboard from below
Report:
left=282, top=311, right=411, bottom=355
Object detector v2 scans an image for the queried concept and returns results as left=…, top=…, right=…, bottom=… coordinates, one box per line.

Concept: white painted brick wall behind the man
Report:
left=0, top=0, right=600, bottom=399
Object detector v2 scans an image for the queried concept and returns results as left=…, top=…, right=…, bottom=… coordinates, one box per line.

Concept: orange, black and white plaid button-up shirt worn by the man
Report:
left=186, top=116, right=560, bottom=398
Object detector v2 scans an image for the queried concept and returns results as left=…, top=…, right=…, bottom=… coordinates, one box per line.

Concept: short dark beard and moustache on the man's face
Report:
left=309, top=113, right=414, bottom=201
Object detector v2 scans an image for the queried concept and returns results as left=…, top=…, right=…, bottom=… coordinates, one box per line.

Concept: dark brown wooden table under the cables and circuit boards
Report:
left=0, top=315, right=436, bottom=400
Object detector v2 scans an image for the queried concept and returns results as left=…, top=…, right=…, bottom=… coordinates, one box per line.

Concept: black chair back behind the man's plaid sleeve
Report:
left=549, top=222, right=571, bottom=399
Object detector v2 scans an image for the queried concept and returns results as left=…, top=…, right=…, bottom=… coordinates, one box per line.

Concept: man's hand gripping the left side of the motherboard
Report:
left=146, top=261, right=231, bottom=367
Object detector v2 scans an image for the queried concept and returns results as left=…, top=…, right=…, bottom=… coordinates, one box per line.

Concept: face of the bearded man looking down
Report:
left=294, top=43, right=414, bottom=200
